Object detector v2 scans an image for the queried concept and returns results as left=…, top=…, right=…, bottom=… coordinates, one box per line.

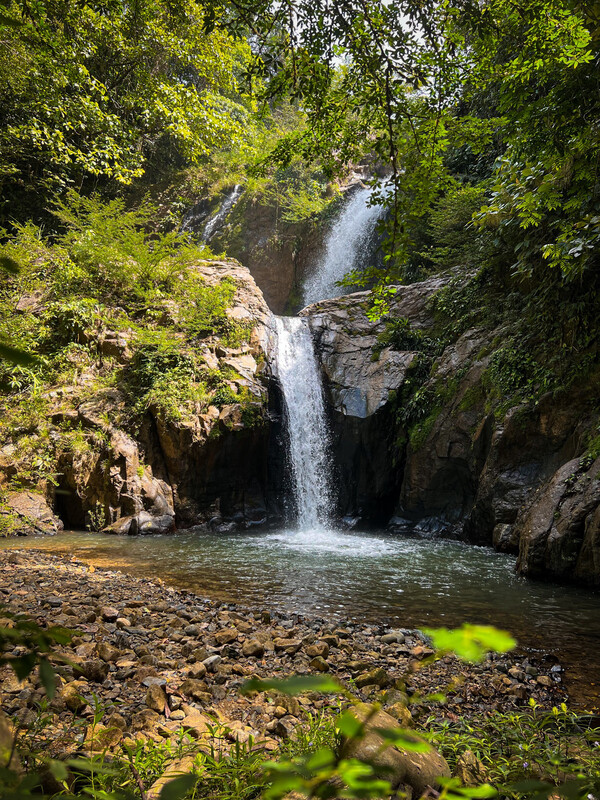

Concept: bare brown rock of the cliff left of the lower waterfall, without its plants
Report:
left=0, top=261, right=271, bottom=534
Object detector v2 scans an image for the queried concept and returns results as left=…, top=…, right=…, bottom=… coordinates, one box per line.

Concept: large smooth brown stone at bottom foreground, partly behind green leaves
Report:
left=345, top=704, right=450, bottom=797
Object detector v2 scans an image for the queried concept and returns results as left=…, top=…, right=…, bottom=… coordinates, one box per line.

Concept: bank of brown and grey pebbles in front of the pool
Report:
left=0, top=550, right=566, bottom=768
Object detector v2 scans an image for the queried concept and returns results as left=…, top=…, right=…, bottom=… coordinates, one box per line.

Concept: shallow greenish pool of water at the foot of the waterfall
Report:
left=0, top=531, right=600, bottom=710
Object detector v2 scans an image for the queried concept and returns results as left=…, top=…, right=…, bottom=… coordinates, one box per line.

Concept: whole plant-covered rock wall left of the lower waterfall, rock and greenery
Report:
left=0, top=196, right=270, bottom=533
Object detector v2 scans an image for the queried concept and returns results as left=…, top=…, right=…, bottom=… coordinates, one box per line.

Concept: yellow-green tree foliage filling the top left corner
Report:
left=0, top=0, right=251, bottom=227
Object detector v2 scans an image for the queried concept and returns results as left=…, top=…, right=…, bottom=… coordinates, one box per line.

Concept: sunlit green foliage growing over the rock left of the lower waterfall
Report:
left=0, top=194, right=261, bottom=496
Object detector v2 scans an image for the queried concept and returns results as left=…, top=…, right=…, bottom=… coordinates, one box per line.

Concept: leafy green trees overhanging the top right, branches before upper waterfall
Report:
left=213, top=0, right=600, bottom=282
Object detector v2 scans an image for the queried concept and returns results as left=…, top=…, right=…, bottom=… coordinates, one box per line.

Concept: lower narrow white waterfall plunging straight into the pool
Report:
left=275, top=317, right=333, bottom=531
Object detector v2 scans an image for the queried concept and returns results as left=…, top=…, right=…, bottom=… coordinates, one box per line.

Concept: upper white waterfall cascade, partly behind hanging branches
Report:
left=304, top=189, right=383, bottom=305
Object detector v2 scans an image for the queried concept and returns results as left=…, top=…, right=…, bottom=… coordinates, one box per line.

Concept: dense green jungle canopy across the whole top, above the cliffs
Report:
left=0, top=0, right=600, bottom=384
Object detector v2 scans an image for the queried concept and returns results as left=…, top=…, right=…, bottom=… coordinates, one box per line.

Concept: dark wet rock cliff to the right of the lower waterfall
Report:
left=301, top=277, right=600, bottom=584
